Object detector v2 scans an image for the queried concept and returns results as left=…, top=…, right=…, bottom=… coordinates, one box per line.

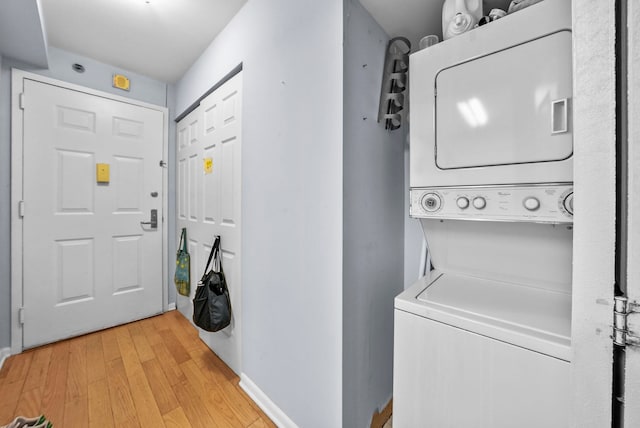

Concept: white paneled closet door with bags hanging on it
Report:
left=177, top=73, right=242, bottom=373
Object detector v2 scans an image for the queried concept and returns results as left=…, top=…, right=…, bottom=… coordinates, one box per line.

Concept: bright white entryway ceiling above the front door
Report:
left=40, top=0, right=247, bottom=83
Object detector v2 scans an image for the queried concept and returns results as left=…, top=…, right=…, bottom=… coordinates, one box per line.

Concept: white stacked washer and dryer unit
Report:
left=393, top=0, right=573, bottom=428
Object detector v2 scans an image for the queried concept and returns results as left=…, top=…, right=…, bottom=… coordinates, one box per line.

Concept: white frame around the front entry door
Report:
left=11, top=68, right=169, bottom=354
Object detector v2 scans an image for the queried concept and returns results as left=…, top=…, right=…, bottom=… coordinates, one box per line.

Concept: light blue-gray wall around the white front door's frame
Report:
left=0, top=48, right=175, bottom=349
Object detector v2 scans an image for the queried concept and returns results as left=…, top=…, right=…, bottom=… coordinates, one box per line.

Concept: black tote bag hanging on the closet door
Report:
left=193, top=236, right=231, bottom=332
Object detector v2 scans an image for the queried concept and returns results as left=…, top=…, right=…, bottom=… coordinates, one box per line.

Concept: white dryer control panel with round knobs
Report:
left=410, top=183, right=573, bottom=223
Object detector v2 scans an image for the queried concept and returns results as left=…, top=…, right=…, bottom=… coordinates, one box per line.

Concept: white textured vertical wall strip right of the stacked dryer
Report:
left=569, top=0, right=616, bottom=428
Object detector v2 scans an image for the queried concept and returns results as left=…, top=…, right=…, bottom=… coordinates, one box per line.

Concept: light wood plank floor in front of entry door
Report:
left=0, top=311, right=275, bottom=428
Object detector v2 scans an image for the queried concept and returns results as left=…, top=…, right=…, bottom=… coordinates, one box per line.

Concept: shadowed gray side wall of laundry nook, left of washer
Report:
left=342, top=0, right=405, bottom=428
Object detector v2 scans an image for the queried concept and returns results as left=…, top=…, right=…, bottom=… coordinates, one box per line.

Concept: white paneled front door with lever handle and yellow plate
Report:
left=23, top=79, right=164, bottom=348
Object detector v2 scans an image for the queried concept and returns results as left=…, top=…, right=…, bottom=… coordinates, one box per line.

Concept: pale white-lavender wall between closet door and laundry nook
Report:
left=176, top=0, right=343, bottom=428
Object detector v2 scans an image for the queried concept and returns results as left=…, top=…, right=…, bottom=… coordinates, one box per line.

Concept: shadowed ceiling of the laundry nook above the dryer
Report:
left=360, top=0, right=510, bottom=50
